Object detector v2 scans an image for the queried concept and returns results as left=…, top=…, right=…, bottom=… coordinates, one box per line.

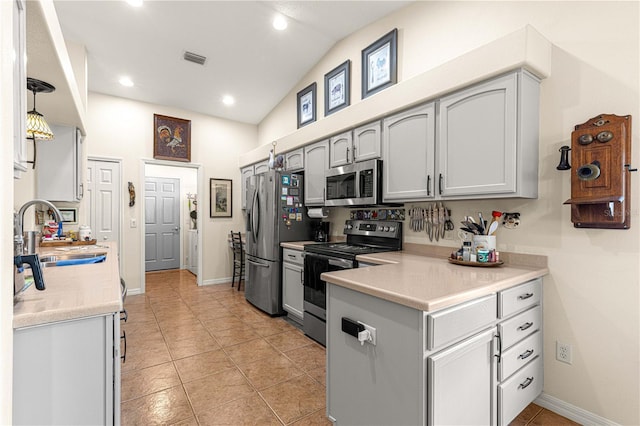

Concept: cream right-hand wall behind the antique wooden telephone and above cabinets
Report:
left=259, top=1, right=640, bottom=424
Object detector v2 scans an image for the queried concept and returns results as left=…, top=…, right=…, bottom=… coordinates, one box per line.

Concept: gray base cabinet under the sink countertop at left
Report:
left=13, top=313, right=120, bottom=425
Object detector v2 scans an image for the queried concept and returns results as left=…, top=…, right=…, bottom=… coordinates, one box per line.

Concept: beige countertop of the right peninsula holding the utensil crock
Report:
left=321, top=249, right=549, bottom=311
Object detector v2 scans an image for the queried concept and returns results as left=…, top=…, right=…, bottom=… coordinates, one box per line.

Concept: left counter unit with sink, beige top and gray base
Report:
left=13, top=242, right=126, bottom=425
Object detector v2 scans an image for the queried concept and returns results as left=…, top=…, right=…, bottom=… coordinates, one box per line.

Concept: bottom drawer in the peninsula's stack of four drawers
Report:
left=498, top=357, right=544, bottom=425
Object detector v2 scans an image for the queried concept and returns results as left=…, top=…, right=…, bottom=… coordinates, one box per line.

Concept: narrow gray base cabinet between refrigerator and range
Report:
left=282, top=248, right=304, bottom=323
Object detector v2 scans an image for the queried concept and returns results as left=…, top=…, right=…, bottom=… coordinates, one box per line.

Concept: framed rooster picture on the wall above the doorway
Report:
left=153, top=114, right=191, bottom=162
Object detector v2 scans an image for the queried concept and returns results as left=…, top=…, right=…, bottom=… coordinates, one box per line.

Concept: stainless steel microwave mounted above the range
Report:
left=324, top=160, right=382, bottom=206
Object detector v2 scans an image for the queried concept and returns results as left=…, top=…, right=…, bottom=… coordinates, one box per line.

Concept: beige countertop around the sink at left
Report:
left=13, top=242, right=122, bottom=328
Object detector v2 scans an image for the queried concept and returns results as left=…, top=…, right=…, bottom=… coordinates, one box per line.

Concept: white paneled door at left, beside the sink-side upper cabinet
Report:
left=85, top=160, right=121, bottom=247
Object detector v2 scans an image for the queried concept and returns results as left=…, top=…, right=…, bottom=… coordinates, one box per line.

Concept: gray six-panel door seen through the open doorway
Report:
left=144, top=177, right=180, bottom=272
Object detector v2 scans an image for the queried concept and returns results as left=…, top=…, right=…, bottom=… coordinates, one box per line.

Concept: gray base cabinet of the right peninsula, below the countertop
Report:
left=327, top=279, right=543, bottom=426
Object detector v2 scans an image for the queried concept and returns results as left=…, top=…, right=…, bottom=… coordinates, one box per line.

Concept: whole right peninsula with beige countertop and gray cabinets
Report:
left=322, top=247, right=549, bottom=425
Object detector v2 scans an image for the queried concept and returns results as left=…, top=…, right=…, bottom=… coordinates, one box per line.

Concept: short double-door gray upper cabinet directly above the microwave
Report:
left=329, top=121, right=381, bottom=167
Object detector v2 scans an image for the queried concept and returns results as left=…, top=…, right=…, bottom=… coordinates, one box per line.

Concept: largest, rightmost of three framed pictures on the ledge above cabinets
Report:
left=362, top=28, right=398, bottom=99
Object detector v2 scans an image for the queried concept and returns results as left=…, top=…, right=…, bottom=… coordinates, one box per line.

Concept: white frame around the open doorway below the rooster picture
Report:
left=139, top=159, right=204, bottom=293
